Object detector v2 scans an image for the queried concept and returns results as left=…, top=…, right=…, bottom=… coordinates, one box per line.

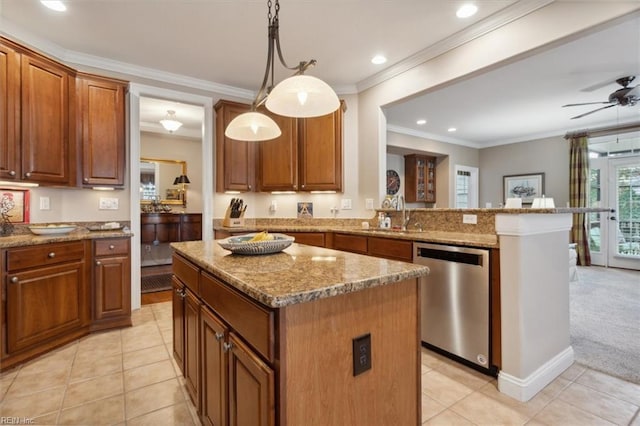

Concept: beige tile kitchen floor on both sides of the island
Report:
left=0, top=303, right=640, bottom=426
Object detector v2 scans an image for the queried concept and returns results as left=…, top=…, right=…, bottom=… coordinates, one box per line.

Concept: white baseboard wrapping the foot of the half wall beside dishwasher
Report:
left=498, top=346, right=574, bottom=402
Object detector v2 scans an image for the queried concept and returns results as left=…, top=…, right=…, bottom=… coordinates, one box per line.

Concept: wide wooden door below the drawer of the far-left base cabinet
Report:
left=6, top=262, right=89, bottom=353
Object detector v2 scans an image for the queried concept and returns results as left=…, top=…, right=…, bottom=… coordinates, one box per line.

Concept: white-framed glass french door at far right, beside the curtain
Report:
left=588, top=155, right=640, bottom=270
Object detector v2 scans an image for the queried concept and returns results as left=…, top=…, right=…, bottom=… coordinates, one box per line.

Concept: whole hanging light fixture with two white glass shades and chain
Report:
left=224, top=0, right=340, bottom=141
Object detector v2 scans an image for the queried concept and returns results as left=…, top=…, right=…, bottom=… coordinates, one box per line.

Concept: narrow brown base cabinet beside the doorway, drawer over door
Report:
left=91, top=238, right=131, bottom=331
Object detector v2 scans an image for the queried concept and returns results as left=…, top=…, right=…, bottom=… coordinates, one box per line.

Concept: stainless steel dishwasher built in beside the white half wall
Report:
left=413, top=243, right=493, bottom=373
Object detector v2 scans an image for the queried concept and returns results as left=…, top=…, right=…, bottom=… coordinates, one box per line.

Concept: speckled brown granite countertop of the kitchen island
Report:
left=171, top=241, right=429, bottom=308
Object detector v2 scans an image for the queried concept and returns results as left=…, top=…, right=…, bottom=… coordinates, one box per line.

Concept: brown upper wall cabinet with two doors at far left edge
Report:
left=0, top=38, right=77, bottom=186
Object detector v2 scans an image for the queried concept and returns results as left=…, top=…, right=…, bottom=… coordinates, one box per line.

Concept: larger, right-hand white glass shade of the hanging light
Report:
left=265, top=75, right=340, bottom=117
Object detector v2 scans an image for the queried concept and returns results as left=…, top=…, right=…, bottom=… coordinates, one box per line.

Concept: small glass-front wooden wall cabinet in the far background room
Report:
left=404, top=154, right=436, bottom=203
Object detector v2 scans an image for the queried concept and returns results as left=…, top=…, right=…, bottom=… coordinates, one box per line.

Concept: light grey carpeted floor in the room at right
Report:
left=570, top=266, right=640, bottom=384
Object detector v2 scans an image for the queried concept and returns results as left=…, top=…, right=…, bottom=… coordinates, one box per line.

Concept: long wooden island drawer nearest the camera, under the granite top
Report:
left=200, top=272, right=275, bottom=362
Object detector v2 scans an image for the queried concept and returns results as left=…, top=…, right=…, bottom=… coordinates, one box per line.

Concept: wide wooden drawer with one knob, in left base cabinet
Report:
left=7, top=241, right=84, bottom=271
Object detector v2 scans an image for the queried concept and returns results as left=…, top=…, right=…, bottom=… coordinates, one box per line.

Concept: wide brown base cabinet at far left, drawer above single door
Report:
left=1, top=241, right=91, bottom=369
